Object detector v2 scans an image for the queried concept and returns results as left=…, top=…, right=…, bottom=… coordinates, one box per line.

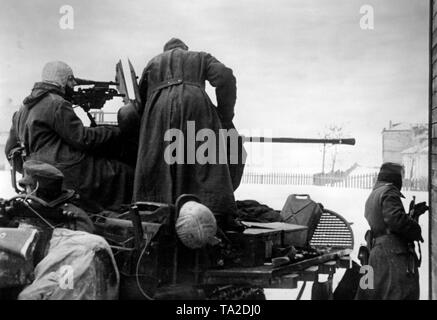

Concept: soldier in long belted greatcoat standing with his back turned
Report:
left=134, top=38, right=242, bottom=229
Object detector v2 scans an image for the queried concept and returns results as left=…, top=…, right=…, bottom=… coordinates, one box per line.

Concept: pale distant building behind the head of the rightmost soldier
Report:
left=382, top=121, right=428, bottom=165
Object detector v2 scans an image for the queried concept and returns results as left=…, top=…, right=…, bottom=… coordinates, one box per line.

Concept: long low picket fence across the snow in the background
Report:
left=241, top=171, right=428, bottom=191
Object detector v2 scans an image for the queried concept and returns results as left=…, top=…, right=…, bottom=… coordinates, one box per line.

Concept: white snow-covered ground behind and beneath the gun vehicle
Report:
left=0, top=171, right=428, bottom=300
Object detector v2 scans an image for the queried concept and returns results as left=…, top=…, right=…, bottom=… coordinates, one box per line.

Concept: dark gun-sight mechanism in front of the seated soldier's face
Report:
left=72, top=78, right=124, bottom=127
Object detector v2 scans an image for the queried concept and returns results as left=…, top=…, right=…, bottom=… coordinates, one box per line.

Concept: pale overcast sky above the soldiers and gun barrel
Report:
left=0, top=0, right=428, bottom=167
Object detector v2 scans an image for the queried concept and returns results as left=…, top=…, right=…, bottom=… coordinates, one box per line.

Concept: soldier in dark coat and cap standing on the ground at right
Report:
left=357, top=163, right=427, bottom=300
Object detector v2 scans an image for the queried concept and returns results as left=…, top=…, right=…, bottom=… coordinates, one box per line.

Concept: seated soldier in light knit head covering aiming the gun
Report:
left=5, top=61, right=134, bottom=211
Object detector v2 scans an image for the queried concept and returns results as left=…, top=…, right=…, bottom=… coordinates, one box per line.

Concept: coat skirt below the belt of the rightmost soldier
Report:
left=356, top=235, right=420, bottom=300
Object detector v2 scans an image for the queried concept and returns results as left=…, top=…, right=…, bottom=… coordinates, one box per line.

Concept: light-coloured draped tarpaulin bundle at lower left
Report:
left=18, top=228, right=119, bottom=300
